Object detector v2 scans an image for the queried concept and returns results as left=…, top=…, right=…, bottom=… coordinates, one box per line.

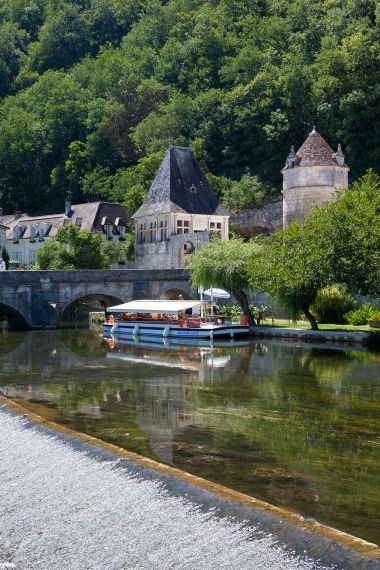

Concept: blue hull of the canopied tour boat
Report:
left=103, top=323, right=249, bottom=339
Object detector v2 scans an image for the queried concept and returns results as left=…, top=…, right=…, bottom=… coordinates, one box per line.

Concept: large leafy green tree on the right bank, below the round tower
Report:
left=250, top=171, right=380, bottom=329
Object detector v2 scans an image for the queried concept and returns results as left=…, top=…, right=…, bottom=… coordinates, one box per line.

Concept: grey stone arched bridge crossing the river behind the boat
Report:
left=0, top=269, right=191, bottom=329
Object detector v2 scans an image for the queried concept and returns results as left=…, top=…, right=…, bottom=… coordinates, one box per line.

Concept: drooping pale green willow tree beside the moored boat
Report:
left=189, top=238, right=256, bottom=325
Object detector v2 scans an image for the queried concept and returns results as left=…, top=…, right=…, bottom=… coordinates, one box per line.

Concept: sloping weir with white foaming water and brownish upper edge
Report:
left=0, top=399, right=379, bottom=570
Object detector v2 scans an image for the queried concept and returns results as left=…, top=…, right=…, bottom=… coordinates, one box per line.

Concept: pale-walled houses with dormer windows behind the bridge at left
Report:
left=0, top=200, right=130, bottom=266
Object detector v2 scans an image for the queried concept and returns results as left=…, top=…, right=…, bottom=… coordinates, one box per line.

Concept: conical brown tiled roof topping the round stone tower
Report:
left=285, top=127, right=347, bottom=169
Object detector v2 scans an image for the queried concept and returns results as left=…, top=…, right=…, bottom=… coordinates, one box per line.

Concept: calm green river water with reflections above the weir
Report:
left=0, top=330, right=380, bottom=543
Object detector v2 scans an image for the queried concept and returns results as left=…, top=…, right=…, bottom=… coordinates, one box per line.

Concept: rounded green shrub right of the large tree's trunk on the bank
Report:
left=311, top=284, right=358, bottom=324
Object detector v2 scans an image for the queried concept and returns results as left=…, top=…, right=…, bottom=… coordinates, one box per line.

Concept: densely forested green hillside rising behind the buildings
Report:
left=0, top=0, right=380, bottom=213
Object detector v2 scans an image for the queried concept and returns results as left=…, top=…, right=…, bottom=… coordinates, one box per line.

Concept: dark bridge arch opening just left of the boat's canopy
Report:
left=59, top=293, right=124, bottom=328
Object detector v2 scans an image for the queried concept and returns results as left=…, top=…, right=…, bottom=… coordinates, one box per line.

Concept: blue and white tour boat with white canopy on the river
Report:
left=103, top=300, right=249, bottom=340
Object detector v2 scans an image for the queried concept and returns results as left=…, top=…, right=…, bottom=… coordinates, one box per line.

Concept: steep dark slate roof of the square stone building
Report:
left=133, top=146, right=227, bottom=218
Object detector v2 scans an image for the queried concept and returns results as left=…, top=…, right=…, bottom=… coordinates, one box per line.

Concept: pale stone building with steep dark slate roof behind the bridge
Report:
left=133, top=146, right=229, bottom=269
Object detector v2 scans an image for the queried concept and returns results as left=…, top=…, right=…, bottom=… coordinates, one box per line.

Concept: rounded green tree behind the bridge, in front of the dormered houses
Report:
left=37, top=224, right=120, bottom=269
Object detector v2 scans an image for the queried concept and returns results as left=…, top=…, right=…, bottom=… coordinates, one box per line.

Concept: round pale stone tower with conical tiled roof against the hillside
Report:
left=281, top=128, right=349, bottom=228
